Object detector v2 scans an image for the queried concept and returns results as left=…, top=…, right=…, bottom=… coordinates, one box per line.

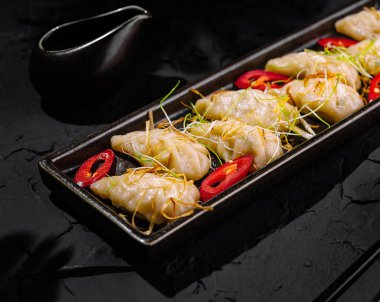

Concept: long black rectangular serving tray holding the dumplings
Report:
left=39, top=0, right=380, bottom=251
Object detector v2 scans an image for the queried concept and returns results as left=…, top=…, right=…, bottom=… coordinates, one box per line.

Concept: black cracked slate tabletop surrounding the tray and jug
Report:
left=0, top=0, right=380, bottom=302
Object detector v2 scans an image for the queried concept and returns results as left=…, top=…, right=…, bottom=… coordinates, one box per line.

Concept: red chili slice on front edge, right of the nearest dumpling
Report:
left=199, top=155, right=253, bottom=201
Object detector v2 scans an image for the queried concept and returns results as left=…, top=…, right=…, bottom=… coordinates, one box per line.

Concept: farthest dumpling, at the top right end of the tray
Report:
left=335, top=7, right=380, bottom=41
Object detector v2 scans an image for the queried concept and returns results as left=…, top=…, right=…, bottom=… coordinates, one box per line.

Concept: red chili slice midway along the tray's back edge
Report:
left=235, top=69, right=290, bottom=91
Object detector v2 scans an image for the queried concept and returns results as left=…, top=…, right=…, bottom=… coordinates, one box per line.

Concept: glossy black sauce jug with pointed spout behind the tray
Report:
left=29, top=6, right=151, bottom=102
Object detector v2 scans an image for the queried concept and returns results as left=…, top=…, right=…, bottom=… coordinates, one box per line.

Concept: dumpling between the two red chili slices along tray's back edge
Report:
left=265, top=51, right=361, bottom=90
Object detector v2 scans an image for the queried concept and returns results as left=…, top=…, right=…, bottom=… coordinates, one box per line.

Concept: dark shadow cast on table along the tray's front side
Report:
left=51, top=123, right=380, bottom=297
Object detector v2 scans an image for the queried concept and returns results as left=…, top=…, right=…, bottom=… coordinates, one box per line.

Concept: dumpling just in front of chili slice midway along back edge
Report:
left=195, top=88, right=312, bottom=138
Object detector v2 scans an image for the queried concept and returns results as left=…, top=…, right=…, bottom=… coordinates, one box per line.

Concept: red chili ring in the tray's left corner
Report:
left=74, top=149, right=115, bottom=187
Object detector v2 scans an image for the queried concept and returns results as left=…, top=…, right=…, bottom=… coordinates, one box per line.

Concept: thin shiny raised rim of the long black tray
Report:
left=38, top=0, right=380, bottom=247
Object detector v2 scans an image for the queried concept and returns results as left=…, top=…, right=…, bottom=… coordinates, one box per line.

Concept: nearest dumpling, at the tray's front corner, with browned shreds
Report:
left=90, top=170, right=200, bottom=224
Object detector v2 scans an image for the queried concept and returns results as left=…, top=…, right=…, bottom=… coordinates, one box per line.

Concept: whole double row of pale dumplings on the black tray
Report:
left=90, top=9, right=380, bottom=233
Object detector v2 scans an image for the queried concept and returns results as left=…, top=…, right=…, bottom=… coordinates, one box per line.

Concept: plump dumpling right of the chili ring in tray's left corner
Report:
left=111, top=128, right=211, bottom=180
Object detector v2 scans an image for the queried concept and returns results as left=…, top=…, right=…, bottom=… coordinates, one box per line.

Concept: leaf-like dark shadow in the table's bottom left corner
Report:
left=0, top=232, right=72, bottom=301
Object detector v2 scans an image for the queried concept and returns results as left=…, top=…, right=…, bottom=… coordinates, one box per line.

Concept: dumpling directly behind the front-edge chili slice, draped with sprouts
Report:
left=190, top=120, right=283, bottom=169
